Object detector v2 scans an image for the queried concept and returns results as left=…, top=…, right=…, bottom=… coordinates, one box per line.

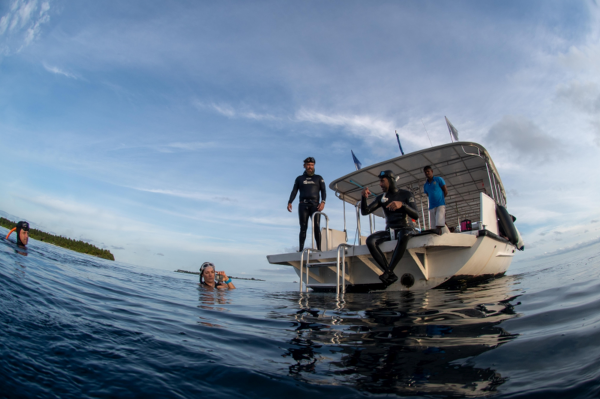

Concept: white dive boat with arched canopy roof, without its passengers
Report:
left=267, top=141, right=524, bottom=293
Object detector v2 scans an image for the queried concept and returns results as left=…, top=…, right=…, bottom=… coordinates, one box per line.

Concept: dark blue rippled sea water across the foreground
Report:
left=0, top=228, right=600, bottom=398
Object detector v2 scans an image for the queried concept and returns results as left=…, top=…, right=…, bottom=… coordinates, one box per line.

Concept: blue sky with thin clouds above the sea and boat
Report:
left=0, top=0, right=600, bottom=280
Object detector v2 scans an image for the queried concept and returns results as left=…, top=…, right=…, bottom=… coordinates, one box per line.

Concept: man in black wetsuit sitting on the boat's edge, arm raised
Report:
left=360, top=170, right=419, bottom=287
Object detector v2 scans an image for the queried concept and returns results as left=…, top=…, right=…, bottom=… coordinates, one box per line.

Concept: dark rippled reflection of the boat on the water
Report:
left=269, top=277, right=519, bottom=396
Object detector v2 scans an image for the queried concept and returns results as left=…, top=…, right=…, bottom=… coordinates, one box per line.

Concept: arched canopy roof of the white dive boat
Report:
left=329, top=141, right=506, bottom=226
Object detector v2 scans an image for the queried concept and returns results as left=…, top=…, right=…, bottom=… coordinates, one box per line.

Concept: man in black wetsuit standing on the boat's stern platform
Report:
left=288, top=157, right=327, bottom=251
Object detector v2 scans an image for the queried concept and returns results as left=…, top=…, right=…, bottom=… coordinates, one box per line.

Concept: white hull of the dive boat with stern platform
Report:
left=267, top=230, right=516, bottom=291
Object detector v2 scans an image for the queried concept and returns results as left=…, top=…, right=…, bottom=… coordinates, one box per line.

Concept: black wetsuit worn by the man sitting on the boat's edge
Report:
left=360, top=186, right=419, bottom=281
